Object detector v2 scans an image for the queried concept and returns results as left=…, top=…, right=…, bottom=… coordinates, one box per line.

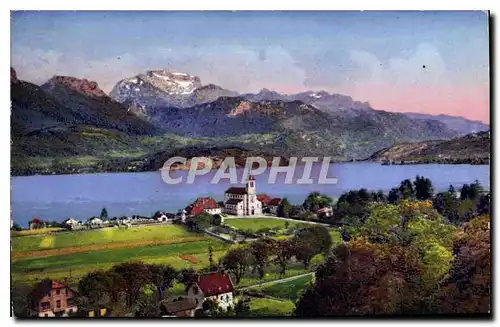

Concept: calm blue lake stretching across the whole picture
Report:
left=11, top=162, right=490, bottom=226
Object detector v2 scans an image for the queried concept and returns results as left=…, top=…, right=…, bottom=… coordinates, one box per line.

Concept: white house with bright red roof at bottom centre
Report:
left=187, top=271, right=234, bottom=310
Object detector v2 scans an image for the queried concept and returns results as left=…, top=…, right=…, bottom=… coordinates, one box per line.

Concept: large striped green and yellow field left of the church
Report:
left=11, top=225, right=229, bottom=282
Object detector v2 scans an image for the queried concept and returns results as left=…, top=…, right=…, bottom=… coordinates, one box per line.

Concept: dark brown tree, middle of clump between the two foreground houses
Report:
left=111, top=262, right=151, bottom=307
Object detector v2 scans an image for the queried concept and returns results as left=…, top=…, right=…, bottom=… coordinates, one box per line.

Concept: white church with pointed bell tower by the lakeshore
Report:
left=224, top=176, right=262, bottom=216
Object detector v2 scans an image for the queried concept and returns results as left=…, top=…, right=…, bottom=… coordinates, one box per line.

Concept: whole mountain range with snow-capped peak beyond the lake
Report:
left=11, top=69, right=489, bottom=174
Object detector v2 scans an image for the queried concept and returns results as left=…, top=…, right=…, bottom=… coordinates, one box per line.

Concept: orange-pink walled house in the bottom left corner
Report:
left=28, top=279, right=78, bottom=317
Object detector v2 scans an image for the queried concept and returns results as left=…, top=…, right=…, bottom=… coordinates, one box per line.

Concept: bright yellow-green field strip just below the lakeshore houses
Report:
left=12, top=225, right=196, bottom=252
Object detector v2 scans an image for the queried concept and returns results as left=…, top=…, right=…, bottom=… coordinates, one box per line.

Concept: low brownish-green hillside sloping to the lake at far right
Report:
left=367, top=131, right=491, bottom=164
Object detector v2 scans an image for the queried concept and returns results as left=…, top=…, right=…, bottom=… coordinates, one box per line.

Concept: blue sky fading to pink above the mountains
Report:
left=11, top=11, right=490, bottom=123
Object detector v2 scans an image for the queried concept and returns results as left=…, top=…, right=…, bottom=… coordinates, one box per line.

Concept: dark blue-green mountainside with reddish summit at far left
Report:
left=11, top=69, right=161, bottom=175
